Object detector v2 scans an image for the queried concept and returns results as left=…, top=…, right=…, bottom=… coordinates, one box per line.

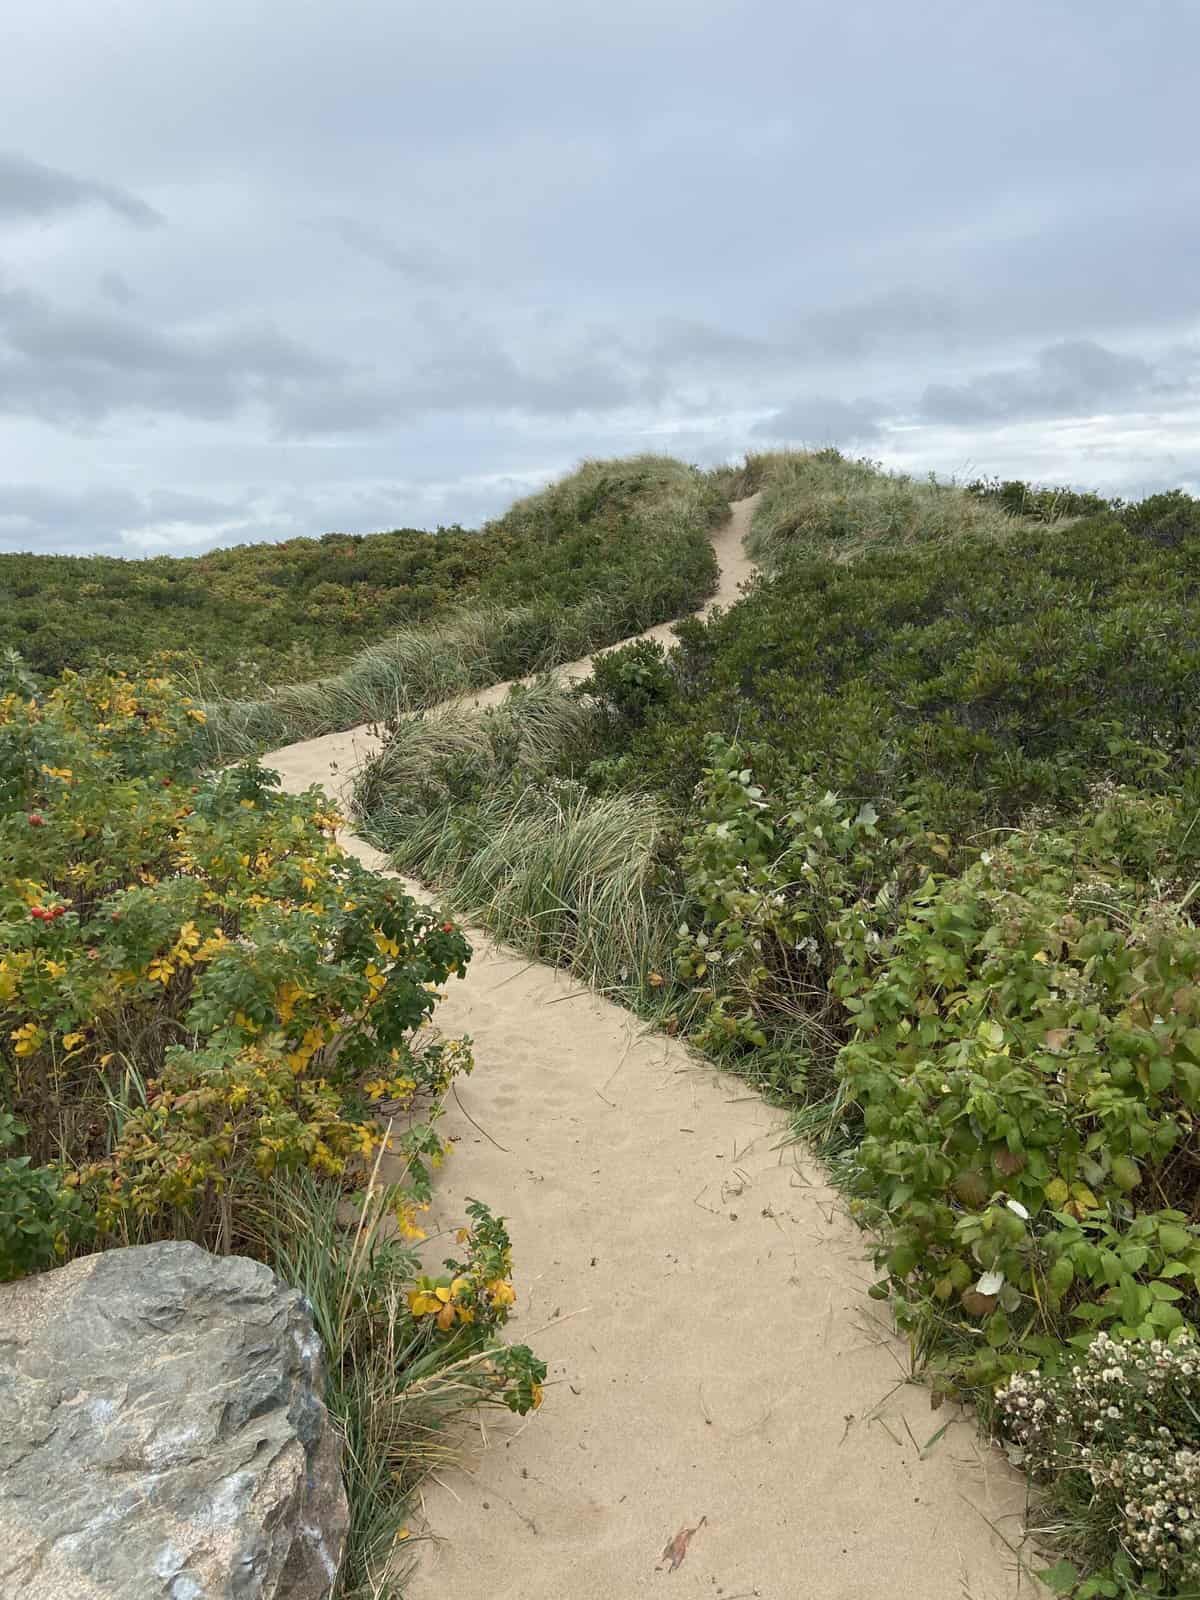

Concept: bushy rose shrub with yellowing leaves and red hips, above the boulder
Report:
left=0, top=656, right=480, bottom=1272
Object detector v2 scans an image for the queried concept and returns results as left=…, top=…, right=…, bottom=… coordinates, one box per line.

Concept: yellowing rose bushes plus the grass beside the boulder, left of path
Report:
left=0, top=664, right=544, bottom=1597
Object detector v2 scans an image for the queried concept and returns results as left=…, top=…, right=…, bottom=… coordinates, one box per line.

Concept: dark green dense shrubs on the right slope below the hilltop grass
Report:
left=601, top=517, right=1200, bottom=837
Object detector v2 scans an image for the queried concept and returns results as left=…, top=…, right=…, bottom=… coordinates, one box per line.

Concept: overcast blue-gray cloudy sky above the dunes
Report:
left=0, top=0, right=1200, bottom=555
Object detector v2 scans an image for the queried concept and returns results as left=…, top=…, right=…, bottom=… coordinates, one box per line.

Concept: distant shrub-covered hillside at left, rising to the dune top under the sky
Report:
left=0, top=458, right=723, bottom=698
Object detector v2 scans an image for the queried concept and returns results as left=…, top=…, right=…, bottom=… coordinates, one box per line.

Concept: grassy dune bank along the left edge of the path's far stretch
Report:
left=208, top=456, right=728, bottom=755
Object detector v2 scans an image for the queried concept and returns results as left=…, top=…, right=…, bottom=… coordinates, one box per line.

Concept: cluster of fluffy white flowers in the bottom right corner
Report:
left=997, top=1330, right=1200, bottom=1589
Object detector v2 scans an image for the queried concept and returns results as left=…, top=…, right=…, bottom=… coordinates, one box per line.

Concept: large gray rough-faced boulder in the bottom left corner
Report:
left=0, top=1243, right=347, bottom=1600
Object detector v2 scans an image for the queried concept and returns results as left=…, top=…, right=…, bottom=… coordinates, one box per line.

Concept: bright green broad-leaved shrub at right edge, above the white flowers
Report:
left=830, top=790, right=1200, bottom=1386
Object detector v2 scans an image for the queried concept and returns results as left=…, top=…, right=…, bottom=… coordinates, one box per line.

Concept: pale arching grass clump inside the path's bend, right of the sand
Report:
left=357, top=680, right=674, bottom=994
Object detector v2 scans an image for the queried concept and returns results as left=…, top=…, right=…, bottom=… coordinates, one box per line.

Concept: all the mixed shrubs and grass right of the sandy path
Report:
left=358, top=453, right=1200, bottom=1600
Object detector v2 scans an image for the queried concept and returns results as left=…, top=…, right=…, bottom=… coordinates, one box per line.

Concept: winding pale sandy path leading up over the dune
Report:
left=264, top=501, right=1034, bottom=1600
